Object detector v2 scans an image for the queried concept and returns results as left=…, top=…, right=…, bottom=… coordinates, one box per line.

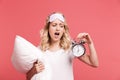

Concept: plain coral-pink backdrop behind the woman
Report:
left=0, top=0, right=120, bottom=80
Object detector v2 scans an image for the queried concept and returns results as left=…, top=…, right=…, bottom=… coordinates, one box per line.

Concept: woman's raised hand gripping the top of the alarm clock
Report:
left=77, top=33, right=92, bottom=44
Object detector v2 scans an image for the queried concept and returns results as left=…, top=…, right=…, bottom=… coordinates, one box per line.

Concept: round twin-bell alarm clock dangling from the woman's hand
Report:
left=72, top=40, right=86, bottom=57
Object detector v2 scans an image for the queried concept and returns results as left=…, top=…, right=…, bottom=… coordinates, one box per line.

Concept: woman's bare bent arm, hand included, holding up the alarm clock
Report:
left=77, top=33, right=99, bottom=67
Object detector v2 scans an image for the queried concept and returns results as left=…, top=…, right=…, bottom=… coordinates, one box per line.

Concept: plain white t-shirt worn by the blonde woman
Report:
left=41, top=49, right=74, bottom=80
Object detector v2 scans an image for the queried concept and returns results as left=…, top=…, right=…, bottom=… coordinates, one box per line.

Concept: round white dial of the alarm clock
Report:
left=73, top=44, right=85, bottom=57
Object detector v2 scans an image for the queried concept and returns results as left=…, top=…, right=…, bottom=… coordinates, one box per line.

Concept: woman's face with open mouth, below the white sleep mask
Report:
left=49, top=19, right=65, bottom=42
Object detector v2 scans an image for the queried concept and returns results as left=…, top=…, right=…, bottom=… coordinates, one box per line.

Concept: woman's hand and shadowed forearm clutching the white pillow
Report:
left=26, top=60, right=44, bottom=80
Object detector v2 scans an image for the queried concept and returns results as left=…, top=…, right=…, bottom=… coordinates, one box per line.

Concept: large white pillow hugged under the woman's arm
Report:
left=11, top=35, right=52, bottom=80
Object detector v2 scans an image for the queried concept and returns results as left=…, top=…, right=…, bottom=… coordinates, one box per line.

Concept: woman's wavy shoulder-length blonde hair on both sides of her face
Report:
left=40, top=12, right=71, bottom=51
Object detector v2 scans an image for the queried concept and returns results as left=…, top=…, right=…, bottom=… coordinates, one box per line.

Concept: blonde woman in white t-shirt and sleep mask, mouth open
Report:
left=26, top=13, right=99, bottom=80
